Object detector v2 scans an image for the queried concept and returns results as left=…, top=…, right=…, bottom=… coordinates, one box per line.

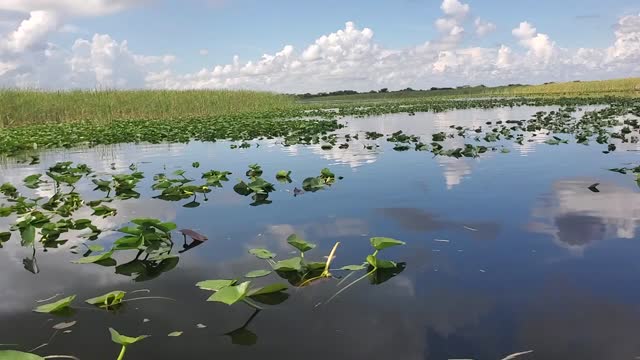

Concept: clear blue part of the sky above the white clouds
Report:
left=57, top=0, right=640, bottom=71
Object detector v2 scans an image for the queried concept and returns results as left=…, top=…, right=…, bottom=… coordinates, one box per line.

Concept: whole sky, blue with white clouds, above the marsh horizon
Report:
left=0, top=0, right=640, bottom=93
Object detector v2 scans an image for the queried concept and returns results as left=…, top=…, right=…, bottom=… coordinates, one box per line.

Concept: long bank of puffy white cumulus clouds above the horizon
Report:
left=0, top=0, right=640, bottom=93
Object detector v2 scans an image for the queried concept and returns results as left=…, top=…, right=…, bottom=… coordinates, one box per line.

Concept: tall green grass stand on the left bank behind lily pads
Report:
left=0, top=90, right=295, bottom=126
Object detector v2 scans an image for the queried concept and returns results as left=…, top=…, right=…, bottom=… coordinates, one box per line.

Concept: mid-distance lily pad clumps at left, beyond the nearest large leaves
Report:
left=0, top=162, right=336, bottom=255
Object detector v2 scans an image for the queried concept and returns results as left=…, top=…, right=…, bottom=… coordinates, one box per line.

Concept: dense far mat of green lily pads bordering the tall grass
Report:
left=0, top=97, right=639, bottom=155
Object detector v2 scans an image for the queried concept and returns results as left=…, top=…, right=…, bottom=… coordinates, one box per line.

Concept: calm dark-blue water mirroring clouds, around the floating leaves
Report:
left=0, top=107, right=640, bottom=360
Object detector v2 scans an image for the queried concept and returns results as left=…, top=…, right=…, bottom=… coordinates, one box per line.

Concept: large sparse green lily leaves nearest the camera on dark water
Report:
left=0, top=232, right=405, bottom=360
